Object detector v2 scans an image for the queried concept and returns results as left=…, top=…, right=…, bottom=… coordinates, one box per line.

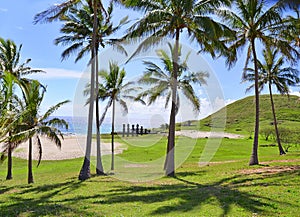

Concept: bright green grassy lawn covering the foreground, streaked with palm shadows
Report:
left=0, top=136, right=300, bottom=217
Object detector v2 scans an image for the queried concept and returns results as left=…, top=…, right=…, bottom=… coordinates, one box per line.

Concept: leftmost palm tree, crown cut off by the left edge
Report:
left=0, top=38, right=42, bottom=179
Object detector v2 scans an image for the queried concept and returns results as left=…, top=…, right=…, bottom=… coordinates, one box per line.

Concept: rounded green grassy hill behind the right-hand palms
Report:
left=182, top=95, right=300, bottom=135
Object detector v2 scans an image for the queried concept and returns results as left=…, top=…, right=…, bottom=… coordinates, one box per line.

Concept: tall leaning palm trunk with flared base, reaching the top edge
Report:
left=78, top=0, right=97, bottom=181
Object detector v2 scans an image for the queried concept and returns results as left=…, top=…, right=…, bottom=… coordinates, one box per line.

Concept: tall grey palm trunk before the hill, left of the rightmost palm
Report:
left=249, top=39, right=259, bottom=166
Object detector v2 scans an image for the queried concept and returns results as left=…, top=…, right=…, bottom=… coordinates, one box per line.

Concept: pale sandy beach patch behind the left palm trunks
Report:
left=13, top=135, right=126, bottom=160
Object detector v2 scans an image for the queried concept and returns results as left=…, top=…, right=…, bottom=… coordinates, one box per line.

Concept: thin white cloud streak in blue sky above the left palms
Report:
left=30, top=68, right=82, bottom=79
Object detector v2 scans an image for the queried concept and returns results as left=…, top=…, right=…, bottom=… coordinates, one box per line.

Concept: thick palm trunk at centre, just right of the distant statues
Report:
left=164, top=29, right=180, bottom=177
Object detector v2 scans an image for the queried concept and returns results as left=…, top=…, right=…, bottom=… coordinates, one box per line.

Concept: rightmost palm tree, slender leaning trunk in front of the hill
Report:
left=244, top=47, right=300, bottom=155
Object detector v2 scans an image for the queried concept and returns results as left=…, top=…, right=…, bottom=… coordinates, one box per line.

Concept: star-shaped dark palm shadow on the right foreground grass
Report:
left=101, top=171, right=296, bottom=216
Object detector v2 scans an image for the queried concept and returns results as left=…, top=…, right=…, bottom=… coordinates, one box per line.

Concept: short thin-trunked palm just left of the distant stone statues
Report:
left=98, top=62, right=145, bottom=171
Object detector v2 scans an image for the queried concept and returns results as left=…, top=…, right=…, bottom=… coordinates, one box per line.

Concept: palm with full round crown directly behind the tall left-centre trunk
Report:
left=55, top=0, right=127, bottom=175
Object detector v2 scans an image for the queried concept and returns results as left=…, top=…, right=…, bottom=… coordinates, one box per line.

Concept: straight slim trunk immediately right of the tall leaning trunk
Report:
left=95, top=46, right=104, bottom=175
